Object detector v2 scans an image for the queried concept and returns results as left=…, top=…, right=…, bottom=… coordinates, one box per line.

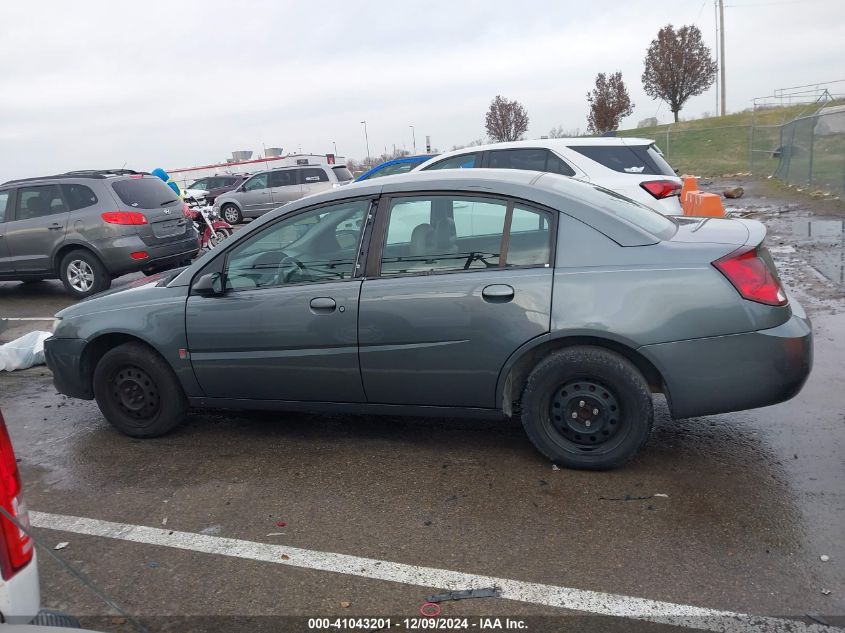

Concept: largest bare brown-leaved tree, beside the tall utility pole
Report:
left=642, top=24, right=717, bottom=123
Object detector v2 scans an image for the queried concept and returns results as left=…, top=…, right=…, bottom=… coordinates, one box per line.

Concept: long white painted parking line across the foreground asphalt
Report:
left=29, top=512, right=842, bottom=633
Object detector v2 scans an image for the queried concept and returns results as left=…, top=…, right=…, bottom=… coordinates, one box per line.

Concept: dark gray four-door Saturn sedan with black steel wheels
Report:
left=45, top=169, right=812, bottom=469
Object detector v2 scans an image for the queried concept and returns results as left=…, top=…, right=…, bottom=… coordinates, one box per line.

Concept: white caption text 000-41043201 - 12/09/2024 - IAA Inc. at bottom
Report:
left=308, top=617, right=528, bottom=631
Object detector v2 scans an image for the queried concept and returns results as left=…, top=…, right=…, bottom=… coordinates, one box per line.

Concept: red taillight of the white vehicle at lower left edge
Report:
left=0, top=414, right=32, bottom=580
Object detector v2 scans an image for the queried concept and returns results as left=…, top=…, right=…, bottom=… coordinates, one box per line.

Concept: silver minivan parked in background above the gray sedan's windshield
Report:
left=214, top=165, right=352, bottom=224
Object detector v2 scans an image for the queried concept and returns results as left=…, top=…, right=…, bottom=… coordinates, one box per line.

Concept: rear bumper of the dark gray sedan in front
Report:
left=640, top=301, right=813, bottom=418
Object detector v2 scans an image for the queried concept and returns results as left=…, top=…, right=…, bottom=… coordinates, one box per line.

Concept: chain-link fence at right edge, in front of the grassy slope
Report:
left=774, top=106, right=845, bottom=194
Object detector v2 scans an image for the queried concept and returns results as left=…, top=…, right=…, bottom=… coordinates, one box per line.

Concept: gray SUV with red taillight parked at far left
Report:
left=0, top=169, right=199, bottom=298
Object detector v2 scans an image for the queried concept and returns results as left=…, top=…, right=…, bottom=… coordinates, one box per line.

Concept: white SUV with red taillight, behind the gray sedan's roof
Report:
left=414, top=137, right=683, bottom=215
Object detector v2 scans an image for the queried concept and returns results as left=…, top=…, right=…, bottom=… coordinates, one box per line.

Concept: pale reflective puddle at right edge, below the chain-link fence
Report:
left=773, top=217, right=845, bottom=286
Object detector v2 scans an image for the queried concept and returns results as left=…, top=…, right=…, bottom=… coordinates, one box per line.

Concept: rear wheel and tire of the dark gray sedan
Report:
left=521, top=347, right=654, bottom=470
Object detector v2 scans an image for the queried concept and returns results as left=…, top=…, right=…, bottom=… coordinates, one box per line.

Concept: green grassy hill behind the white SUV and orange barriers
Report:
left=617, top=102, right=843, bottom=176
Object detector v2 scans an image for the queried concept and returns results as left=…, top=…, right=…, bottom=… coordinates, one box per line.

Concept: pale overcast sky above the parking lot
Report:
left=0, top=0, right=845, bottom=182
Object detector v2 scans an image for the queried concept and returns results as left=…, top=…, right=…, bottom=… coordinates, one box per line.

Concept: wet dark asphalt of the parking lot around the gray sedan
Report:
left=0, top=189, right=845, bottom=631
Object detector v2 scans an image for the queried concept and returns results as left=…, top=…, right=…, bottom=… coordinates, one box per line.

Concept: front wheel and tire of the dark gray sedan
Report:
left=94, top=343, right=188, bottom=438
